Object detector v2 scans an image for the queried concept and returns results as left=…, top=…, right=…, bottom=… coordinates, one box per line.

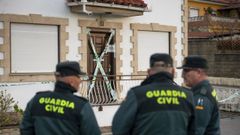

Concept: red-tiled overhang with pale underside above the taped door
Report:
left=67, top=0, right=150, bottom=17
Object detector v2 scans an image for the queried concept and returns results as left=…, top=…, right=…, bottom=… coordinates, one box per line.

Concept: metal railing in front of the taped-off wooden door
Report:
left=79, top=75, right=146, bottom=105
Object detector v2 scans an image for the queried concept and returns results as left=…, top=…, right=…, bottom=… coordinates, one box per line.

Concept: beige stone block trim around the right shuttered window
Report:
left=130, top=23, right=177, bottom=75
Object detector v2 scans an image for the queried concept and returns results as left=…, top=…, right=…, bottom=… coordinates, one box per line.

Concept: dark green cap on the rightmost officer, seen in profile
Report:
left=177, top=56, right=208, bottom=69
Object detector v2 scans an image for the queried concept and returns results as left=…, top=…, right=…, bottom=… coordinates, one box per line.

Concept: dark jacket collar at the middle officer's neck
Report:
left=141, top=72, right=173, bottom=85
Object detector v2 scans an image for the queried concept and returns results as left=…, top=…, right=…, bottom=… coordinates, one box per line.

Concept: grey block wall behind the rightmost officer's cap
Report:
left=188, top=39, right=240, bottom=78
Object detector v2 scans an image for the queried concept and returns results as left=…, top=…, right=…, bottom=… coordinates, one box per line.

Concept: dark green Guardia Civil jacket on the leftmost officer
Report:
left=20, top=82, right=100, bottom=135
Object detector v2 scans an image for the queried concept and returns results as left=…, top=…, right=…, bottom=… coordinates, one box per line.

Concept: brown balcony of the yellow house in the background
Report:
left=188, top=15, right=240, bottom=38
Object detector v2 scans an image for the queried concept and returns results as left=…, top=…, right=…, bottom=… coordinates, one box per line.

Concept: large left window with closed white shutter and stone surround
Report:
left=0, top=14, right=68, bottom=82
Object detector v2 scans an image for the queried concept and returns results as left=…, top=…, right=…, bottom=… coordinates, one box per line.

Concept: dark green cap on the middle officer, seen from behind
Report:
left=150, top=53, right=173, bottom=67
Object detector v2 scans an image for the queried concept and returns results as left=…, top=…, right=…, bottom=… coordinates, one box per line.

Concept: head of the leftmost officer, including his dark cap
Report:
left=55, top=61, right=85, bottom=90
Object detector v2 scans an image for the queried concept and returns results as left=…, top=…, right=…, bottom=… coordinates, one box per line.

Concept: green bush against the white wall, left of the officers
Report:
left=0, top=90, right=23, bottom=127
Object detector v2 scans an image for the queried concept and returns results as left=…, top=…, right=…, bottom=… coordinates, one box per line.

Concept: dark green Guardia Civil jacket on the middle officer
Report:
left=112, top=72, right=195, bottom=135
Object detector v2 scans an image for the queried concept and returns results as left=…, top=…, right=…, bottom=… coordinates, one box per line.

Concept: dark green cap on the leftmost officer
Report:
left=56, top=61, right=86, bottom=77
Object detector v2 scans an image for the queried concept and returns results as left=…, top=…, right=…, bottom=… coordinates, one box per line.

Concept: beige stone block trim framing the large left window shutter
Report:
left=0, top=14, right=68, bottom=82
